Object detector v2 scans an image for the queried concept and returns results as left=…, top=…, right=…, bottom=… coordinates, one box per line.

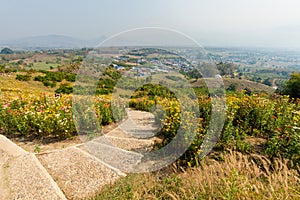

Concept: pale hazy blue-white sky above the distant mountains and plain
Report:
left=0, top=0, right=300, bottom=48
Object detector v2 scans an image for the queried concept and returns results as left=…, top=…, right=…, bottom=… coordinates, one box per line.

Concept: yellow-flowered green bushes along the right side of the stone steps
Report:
left=130, top=91, right=300, bottom=165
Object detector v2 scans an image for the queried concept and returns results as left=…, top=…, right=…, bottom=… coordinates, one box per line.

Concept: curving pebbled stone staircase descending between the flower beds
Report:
left=0, top=110, right=157, bottom=200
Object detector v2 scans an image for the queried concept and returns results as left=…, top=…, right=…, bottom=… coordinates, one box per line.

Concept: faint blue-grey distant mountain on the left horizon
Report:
left=0, top=35, right=104, bottom=49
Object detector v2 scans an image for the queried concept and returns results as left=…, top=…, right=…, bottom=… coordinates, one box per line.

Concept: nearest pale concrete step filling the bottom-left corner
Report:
left=0, top=136, right=66, bottom=200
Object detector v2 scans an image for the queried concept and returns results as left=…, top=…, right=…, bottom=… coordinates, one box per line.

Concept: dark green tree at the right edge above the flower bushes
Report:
left=280, top=73, right=300, bottom=98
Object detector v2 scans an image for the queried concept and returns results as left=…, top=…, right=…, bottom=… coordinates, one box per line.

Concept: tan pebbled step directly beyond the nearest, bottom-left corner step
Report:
left=37, top=147, right=124, bottom=199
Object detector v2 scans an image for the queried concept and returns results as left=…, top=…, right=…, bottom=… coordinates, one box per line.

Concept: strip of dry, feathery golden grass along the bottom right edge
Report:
left=95, top=153, right=300, bottom=200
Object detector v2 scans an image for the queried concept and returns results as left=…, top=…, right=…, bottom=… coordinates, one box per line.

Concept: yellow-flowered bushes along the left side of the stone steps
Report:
left=0, top=91, right=114, bottom=139
